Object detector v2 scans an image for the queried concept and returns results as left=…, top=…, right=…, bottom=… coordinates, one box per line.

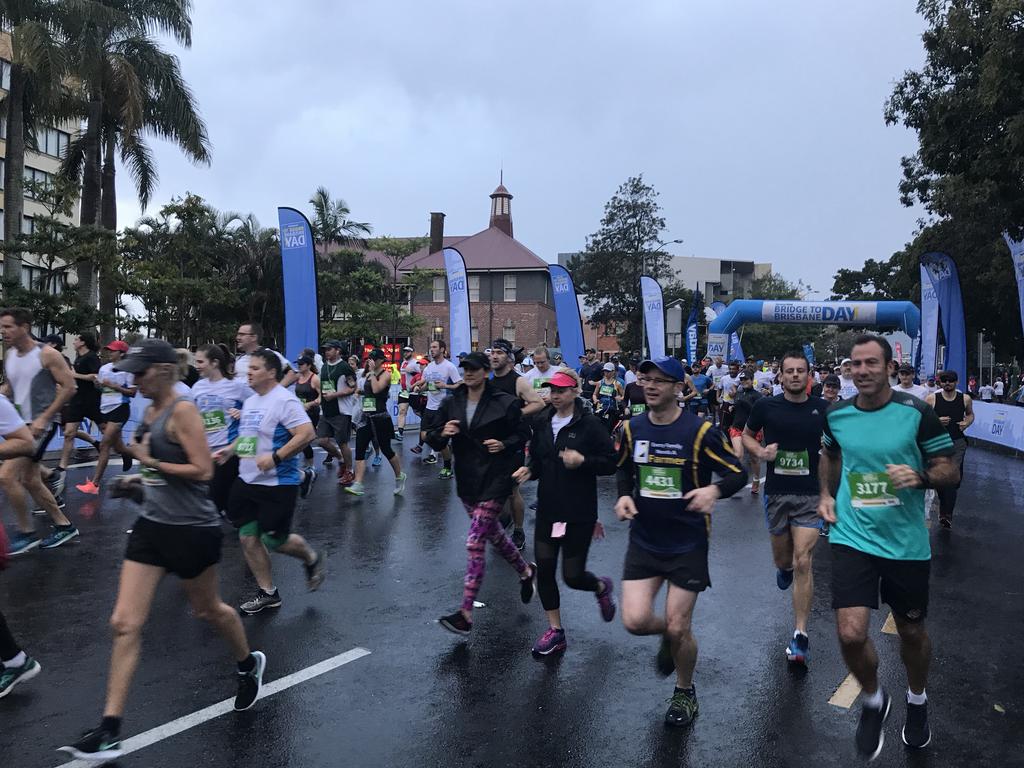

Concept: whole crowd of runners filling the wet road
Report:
left=0, top=308, right=974, bottom=762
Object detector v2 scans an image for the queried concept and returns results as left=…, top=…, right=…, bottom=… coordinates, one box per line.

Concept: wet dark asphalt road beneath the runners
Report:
left=0, top=443, right=1024, bottom=768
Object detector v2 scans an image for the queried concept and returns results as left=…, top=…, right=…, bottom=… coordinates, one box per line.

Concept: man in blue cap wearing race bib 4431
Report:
left=615, top=357, right=746, bottom=726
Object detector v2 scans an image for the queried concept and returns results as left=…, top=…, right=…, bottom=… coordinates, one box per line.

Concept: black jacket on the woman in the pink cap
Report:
left=527, top=398, right=617, bottom=522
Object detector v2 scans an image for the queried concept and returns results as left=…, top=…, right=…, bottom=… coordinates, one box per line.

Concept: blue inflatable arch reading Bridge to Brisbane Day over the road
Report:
left=708, top=299, right=921, bottom=339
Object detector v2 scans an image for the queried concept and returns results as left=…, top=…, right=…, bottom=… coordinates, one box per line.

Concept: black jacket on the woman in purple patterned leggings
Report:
left=427, top=382, right=529, bottom=503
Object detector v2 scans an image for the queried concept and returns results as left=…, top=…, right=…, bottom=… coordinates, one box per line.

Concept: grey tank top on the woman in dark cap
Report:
left=139, top=397, right=220, bottom=527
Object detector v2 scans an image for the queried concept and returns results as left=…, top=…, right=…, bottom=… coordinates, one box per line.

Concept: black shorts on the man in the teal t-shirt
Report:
left=830, top=544, right=932, bottom=622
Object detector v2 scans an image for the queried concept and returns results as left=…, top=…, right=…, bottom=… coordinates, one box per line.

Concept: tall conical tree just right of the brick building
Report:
left=569, top=175, right=672, bottom=349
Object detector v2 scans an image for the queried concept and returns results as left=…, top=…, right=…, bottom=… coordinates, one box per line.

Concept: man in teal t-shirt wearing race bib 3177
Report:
left=818, top=335, right=957, bottom=759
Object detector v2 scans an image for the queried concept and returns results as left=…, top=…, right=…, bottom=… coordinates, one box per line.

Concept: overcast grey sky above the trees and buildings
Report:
left=119, top=0, right=924, bottom=298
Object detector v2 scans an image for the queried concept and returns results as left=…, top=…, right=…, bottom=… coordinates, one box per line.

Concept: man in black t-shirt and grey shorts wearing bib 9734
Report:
left=737, top=351, right=828, bottom=666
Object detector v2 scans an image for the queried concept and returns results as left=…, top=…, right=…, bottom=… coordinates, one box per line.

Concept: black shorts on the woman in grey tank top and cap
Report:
left=125, top=517, right=224, bottom=579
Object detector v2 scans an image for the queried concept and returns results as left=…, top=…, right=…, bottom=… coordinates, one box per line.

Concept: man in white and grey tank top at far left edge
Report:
left=0, top=307, right=78, bottom=555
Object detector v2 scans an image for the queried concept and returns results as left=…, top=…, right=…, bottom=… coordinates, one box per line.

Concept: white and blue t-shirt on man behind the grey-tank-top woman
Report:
left=234, top=384, right=310, bottom=485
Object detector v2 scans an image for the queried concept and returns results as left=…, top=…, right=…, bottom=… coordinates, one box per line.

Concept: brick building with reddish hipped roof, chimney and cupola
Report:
left=403, top=184, right=558, bottom=351
